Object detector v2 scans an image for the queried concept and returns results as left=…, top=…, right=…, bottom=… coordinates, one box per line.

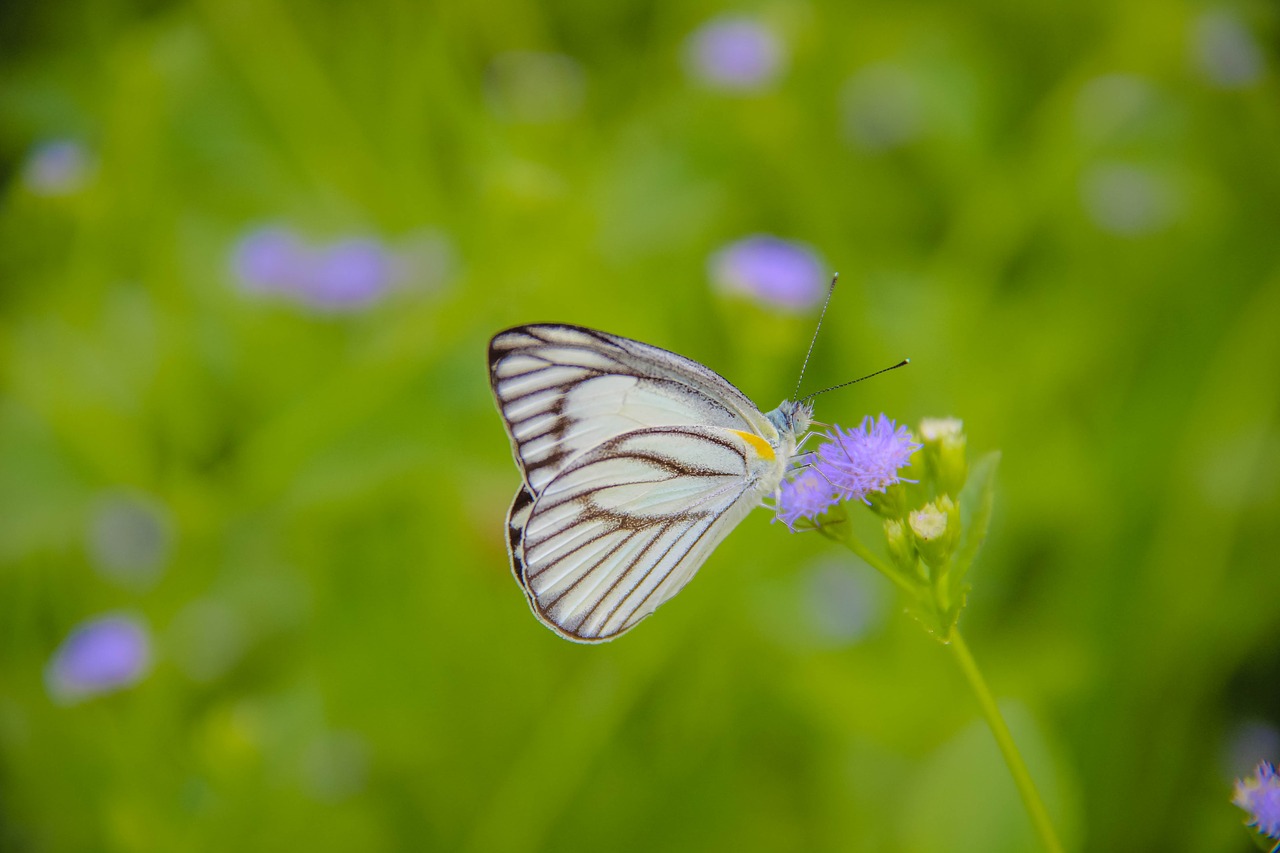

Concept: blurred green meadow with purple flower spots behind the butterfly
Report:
left=0, top=0, right=1280, bottom=852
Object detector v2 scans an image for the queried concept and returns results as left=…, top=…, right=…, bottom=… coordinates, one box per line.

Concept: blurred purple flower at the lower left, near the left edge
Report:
left=45, top=613, right=151, bottom=702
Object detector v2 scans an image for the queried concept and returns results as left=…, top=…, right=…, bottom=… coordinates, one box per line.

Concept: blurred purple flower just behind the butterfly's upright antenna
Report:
left=709, top=234, right=827, bottom=311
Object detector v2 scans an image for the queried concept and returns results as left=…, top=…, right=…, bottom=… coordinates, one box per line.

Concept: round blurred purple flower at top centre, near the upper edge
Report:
left=685, top=15, right=783, bottom=91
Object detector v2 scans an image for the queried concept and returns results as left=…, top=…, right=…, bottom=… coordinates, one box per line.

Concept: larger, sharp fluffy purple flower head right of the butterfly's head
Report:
left=814, top=415, right=920, bottom=501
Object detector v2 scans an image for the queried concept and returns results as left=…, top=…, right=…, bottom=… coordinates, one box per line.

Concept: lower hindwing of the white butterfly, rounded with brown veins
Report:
left=508, top=427, right=772, bottom=643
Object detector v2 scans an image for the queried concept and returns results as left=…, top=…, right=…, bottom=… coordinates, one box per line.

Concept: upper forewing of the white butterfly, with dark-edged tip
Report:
left=489, top=324, right=777, bottom=496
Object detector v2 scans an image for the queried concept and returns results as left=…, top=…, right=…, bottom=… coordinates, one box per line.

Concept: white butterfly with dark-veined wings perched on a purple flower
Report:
left=489, top=324, right=813, bottom=643
